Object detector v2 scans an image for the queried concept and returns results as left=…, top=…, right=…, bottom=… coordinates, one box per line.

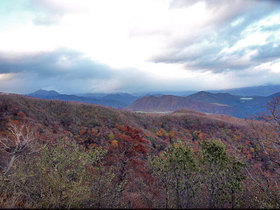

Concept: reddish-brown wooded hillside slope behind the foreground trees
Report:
left=0, top=94, right=279, bottom=206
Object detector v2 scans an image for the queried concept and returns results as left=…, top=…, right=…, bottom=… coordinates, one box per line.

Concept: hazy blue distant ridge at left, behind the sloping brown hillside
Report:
left=27, top=89, right=137, bottom=108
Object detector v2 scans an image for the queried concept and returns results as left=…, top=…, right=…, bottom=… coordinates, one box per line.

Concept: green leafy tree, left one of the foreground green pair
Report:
left=150, top=143, right=200, bottom=208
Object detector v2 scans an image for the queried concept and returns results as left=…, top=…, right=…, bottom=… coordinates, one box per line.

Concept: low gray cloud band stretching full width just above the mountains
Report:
left=0, top=46, right=280, bottom=94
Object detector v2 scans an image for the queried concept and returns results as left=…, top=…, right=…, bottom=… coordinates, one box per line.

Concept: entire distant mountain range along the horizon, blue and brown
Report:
left=27, top=85, right=280, bottom=118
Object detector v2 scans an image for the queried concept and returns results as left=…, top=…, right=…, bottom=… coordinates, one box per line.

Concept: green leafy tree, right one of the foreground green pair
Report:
left=201, top=140, right=245, bottom=208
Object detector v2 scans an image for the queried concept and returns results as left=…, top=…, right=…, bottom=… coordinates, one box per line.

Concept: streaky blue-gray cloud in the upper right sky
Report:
left=152, top=0, right=280, bottom=72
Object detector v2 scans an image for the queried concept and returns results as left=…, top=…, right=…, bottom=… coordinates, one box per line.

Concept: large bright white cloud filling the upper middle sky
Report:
left=0, top=0, right=280, bottom=92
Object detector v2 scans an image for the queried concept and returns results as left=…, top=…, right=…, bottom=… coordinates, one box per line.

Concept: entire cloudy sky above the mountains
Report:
left=0, top=0, right=280, bottom=93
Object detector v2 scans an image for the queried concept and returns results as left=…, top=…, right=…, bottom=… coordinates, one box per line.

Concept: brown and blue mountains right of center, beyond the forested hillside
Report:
left=127, top=91, right=280, bottom=118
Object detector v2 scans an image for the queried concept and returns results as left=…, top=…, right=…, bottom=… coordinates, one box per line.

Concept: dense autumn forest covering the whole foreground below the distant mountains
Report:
left=0, top=94, right=280, bottom=208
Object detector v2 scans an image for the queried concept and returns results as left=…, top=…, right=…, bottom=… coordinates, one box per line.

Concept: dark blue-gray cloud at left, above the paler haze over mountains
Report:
left=0, top=49, right=111, bottom=78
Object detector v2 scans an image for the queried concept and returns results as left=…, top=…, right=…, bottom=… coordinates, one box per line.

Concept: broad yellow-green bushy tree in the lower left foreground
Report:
left=0, top=140, right=116, bottom=208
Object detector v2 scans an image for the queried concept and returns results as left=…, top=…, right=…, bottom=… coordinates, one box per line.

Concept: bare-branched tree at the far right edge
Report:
left=247, top=96, right=280, bottom=208
